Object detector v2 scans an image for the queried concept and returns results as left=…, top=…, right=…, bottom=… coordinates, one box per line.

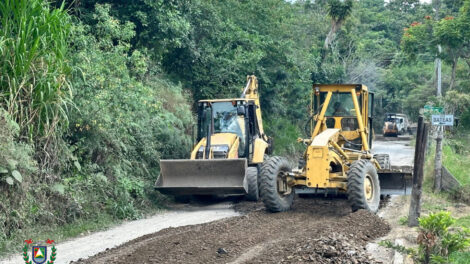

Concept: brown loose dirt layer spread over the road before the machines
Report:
left=78, top=198, right=390, bottom=263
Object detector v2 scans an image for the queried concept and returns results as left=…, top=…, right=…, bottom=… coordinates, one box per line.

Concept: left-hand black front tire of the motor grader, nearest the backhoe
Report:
left=259, top=156, right=295, bottom=212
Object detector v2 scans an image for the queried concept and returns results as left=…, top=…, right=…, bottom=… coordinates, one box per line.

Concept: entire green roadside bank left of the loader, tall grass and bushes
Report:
left=0, top=1, right=193, bottom=253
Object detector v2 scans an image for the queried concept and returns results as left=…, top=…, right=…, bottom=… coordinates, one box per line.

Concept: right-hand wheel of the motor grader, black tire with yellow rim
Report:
left=347, top=159, right=380, bottom=213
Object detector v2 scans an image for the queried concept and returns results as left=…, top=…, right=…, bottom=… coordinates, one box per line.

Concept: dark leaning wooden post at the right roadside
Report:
left=408, top=116, right=429, bottom=226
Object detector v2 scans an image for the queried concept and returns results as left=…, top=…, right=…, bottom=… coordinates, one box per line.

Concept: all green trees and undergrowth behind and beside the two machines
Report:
left=0, top=0, right=470, bottom=254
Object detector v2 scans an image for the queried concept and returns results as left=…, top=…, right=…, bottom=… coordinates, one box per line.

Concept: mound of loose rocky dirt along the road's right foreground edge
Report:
left=253, top=210, right=390, bottom=264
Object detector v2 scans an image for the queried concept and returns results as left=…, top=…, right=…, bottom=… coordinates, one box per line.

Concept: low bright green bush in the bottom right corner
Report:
left=381, top=212, right=470, bottom=264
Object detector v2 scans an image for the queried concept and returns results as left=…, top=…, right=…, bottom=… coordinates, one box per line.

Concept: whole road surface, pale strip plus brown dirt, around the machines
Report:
left=2, top=139, right=413, bottom=263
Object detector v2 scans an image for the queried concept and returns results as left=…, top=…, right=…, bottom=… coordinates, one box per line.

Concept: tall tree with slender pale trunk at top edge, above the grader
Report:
left=323, top=0, right=353, bottom=49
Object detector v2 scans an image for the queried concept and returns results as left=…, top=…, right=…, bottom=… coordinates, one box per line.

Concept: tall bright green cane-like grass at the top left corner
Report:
left=0, top=0, right=72, bottom=145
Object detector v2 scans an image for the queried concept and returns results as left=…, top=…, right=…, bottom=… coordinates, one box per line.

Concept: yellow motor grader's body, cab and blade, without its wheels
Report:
left=287, top=84, right=411, bottom=194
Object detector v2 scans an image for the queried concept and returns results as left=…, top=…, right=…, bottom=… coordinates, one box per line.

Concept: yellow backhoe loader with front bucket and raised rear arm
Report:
left=156, top=75, right=272, bottom=200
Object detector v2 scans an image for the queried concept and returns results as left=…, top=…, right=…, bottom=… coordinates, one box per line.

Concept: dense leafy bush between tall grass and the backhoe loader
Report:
left=62, top=5, right=193, bottom=219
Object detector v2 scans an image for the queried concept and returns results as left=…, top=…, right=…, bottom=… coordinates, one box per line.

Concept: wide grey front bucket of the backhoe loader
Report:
left=155, top=159, right=248, bottom=195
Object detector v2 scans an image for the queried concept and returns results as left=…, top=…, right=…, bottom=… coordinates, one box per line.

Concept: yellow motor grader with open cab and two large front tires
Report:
left=259, top=84, right=411, bottom=212
